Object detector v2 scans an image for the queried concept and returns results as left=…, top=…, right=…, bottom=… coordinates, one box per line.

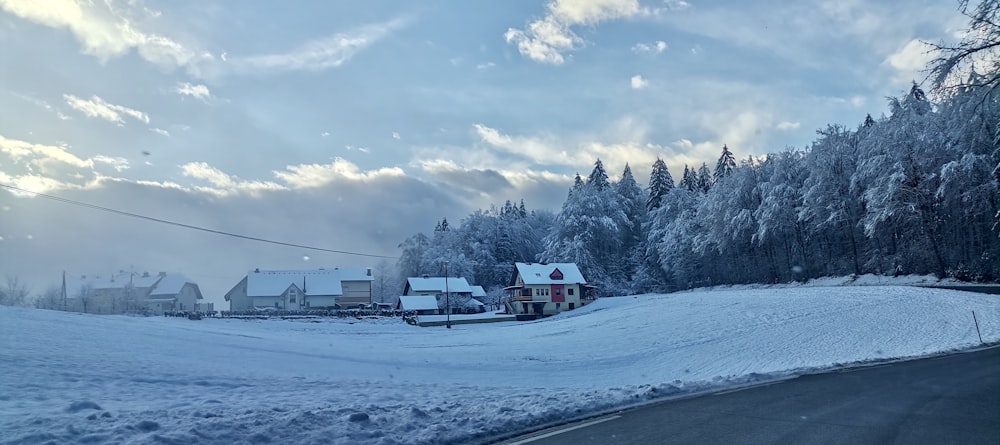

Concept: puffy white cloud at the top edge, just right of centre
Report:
left=504, top=0, right=648, bottom=65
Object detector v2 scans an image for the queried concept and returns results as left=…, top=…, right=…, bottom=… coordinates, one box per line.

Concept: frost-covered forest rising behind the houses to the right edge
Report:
left=397, top=0, right=1000, bottom=295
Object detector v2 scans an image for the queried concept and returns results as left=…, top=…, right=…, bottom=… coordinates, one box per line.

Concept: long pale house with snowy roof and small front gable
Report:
left=225, top=268, right=373, bottom=311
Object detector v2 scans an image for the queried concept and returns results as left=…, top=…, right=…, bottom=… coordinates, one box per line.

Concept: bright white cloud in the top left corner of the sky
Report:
left=0, top=0, right=201, bottom=67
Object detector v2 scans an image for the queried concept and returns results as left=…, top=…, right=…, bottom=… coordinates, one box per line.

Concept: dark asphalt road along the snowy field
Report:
left=504, top=348, right=1000, bottom=445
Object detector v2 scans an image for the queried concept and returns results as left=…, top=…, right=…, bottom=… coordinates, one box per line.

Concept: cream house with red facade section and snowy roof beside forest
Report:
left=504, top=263, right=593, bottom=315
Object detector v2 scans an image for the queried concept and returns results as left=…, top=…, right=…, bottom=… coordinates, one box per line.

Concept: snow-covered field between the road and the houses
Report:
left=0, top=286, right=1000, bottom=444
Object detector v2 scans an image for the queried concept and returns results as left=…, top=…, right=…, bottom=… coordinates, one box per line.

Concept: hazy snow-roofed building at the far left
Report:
left=65, top=271, right=205, bottom=315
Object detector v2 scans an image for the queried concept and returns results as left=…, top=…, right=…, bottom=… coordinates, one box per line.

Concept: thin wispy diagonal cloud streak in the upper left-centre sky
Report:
left=230, top=19, right=405, bottom=71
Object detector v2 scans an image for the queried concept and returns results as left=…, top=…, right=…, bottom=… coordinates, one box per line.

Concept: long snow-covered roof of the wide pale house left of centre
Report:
left=247, top=269, right=346, bottom=297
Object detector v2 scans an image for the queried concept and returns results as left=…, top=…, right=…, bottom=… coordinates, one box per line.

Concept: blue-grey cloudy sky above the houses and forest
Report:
left=0, top=0, right=966, bottom=302
